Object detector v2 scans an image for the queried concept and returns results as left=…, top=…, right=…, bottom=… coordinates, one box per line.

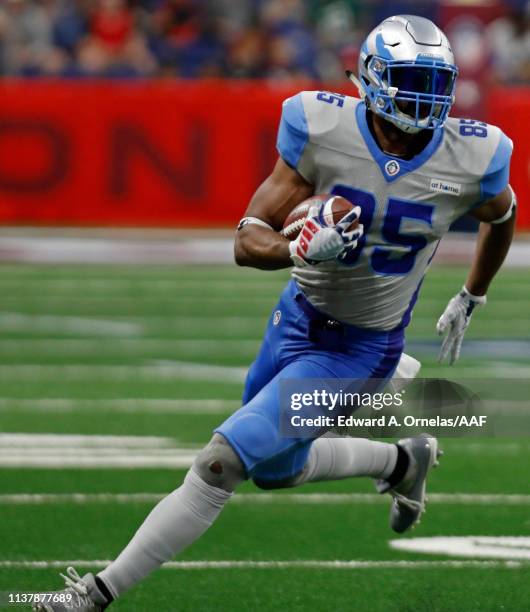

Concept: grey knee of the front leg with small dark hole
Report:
left=192, top=433, right=246, bottom=492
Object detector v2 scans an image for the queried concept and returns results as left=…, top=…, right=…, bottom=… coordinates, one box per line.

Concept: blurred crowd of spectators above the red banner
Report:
left=0, top=0, right=530, bottom=85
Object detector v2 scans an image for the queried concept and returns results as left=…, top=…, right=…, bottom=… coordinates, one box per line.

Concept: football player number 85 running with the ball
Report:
left=35, top=15, right=515, bottom=611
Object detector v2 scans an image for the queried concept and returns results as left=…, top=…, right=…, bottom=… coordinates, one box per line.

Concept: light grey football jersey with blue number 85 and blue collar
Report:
left=278, top=91, right=512, bottom=330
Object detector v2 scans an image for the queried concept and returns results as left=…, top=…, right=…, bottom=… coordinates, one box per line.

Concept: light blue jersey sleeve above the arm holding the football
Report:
left=276, top=93, right=312, bottom=182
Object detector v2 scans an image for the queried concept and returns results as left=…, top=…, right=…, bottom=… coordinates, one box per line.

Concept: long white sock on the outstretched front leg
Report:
left=98, top=469, right=232, bottom=598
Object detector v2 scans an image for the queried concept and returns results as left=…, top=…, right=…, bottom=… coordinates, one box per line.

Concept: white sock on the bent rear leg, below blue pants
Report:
left=297, top=437, right=398, bottom=484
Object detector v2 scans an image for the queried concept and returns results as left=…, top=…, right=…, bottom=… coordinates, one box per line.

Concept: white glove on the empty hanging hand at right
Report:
left=436, top=287, right=486, bottom=365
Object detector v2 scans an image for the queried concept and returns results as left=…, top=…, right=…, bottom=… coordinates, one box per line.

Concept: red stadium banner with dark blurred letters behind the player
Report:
left=0, top=81, right=530, bottom=227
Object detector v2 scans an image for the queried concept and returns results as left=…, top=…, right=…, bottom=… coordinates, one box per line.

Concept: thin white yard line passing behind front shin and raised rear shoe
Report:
left=0, top=492, right=530, bottom=506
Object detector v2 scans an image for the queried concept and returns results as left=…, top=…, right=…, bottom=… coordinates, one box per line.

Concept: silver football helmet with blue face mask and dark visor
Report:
left=347, top=15, right=458, bottom=132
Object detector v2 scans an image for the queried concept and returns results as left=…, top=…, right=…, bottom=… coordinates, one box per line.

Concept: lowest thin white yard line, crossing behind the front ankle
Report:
left=0, top=559, right=528, bottom=570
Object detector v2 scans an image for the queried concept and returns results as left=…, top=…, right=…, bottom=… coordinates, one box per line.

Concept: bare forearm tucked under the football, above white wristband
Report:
left=234, top=225, right=293, bottom=270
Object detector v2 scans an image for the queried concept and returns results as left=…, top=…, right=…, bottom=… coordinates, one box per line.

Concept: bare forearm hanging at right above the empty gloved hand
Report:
left=466, top=217, right=515, bottom=295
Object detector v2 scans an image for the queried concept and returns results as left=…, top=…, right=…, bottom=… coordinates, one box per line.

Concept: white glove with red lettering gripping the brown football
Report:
left=289, top=204, right=363, bottom=267
